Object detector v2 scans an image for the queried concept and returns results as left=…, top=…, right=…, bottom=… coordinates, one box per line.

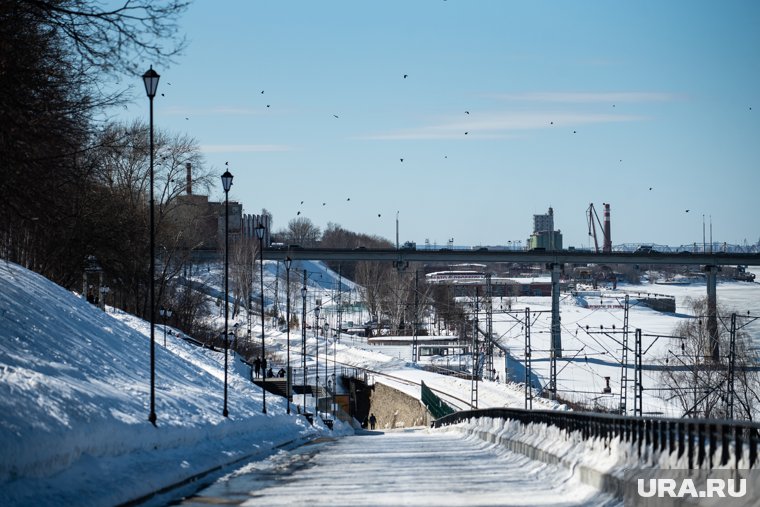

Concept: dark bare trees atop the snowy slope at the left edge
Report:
left=0, top=0, right=218, bottom=334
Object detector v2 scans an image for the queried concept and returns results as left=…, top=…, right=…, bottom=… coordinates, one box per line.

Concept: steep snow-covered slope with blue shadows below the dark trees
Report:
left=0, top=262, right=336, bottom=505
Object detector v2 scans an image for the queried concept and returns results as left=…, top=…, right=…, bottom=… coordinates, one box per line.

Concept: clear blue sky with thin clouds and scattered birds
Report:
left=116, top=0, right=760, bottom=247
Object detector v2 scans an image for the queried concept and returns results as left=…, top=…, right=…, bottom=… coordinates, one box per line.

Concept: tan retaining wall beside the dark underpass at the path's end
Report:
left=369, top=383, right=432, bottom=430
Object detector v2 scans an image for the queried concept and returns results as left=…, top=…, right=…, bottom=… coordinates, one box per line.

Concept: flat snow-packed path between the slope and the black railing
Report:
left=182, top=429, right=622, bottom=506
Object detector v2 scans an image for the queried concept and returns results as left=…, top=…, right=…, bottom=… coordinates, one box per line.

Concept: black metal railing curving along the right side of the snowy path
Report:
left=432, top=408, right=760, bottom=469
